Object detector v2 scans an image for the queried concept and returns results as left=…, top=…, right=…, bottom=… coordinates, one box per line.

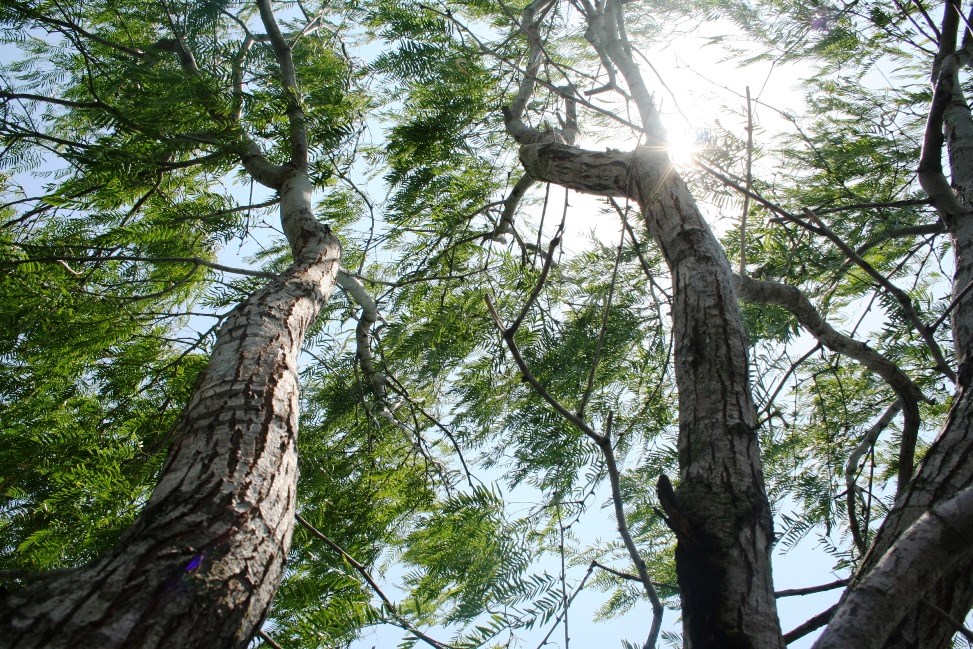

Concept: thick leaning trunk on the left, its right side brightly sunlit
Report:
left=0, top=172, right=340, bottom=649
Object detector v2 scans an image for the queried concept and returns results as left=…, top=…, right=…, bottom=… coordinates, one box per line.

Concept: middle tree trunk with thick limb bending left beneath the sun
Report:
left=520, top=143, right=784, bottom=649
